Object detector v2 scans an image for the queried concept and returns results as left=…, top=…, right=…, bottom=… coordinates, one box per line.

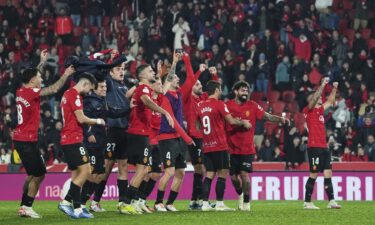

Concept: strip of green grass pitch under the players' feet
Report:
left=0, top=201, right=375, bottom=225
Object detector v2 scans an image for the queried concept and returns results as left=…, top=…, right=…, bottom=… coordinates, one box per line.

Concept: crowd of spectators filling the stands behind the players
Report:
left=0, top=0, right=375, bottom=168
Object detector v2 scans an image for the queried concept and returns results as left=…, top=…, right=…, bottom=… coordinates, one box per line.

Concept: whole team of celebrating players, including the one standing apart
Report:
left=13, top=50, right=340, bottom=218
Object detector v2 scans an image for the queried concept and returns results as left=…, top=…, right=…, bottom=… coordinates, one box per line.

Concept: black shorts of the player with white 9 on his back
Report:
left=203, top=150, right=229, bottom=172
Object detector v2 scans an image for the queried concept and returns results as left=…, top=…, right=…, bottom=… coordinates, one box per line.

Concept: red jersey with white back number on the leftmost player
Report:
left=13, top=87, right=41, bottom=142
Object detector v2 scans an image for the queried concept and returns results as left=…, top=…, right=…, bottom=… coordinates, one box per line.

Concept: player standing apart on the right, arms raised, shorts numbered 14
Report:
left=303, top=78, right=341, bottom=209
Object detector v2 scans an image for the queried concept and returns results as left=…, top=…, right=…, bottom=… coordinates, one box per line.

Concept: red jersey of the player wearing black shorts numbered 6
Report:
left=128, top=84, right=153, bottom=135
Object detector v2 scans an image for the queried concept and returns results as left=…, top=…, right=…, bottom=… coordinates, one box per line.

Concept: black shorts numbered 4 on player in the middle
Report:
left=159, top=138, right=186, bottom=169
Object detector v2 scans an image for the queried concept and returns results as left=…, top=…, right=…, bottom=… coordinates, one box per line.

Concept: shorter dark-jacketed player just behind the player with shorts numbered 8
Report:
left=81, top=77, right=129, bottom=212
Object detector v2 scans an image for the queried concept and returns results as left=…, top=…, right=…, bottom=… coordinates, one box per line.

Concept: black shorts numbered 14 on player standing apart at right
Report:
left=307, top=148, right=332, bottom=173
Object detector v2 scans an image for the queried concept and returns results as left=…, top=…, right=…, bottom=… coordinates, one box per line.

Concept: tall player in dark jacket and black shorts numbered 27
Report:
left=90, top=55, right=135, bottom=214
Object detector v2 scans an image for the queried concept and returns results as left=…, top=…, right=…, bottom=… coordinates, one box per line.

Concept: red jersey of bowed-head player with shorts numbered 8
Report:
left=60, top=88, right=83, bottom=145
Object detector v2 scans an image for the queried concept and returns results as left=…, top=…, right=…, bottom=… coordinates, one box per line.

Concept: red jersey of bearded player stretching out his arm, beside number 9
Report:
left=226, top=100, right=265, bottom=155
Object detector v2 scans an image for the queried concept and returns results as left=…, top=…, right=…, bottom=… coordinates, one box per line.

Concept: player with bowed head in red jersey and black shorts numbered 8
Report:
left=58, top=73, right=105, bottom=219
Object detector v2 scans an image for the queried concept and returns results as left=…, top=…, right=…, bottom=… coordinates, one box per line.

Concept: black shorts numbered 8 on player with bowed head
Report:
left=61, top=143, right=89, bottom=170
